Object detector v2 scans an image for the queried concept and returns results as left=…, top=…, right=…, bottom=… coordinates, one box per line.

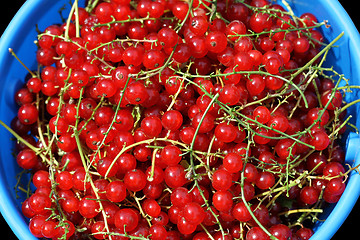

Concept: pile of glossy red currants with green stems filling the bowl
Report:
left=4, top=0, right=351, bottom=240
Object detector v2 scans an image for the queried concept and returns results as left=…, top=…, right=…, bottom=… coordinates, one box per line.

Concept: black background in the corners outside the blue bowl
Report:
left=0, top=0, right=360, bottom=240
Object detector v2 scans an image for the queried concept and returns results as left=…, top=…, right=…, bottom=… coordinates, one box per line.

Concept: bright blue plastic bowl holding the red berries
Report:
left=0, top=0, right=360, bottom=240
